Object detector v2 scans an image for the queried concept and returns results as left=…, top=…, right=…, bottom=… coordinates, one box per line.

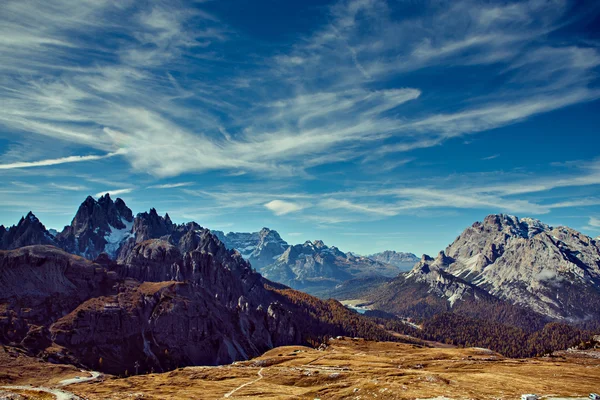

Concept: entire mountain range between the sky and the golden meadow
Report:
left=0, top=195, right=600, bottom=374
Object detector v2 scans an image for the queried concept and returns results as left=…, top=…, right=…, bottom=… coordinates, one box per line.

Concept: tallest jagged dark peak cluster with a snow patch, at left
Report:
left=57, top=193, right=133, bottom=259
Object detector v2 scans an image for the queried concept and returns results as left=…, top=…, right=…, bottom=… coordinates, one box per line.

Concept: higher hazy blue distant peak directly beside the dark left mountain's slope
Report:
left=212, top=228, right=289, bottom=271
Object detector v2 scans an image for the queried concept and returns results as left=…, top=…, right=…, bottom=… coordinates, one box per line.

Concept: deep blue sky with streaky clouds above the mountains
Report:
left=0, top=0, right=600, bottom=254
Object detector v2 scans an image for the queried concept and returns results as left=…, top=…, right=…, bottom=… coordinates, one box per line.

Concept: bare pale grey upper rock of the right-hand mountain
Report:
left=444, top=214, right=600, bottom=319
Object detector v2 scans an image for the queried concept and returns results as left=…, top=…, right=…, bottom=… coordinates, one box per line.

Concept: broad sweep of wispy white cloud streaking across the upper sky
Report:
left=0, top=0, right=600, bottom=177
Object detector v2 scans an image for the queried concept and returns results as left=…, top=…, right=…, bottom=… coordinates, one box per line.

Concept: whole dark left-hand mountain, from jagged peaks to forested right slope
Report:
left=0, top=195, right=404, bottom=374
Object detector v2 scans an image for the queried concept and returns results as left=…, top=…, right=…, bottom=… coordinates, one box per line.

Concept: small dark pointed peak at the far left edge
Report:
left=0, top=211, right=56, bottom=250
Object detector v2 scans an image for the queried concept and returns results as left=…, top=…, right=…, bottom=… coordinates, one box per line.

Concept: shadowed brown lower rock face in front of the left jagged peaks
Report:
left=0, top=244, right=302, bottom=373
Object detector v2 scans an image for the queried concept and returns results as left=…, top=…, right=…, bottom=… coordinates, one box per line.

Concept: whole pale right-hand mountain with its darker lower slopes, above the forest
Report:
left=358, top=214, right=600, bottom=325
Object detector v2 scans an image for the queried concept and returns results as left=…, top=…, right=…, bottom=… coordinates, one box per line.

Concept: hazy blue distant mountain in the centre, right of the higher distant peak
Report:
left=262, top=240, right=398, bottom=294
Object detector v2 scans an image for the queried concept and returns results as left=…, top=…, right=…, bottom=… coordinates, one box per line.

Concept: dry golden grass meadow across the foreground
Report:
left=63, top=338, right=600, bottom=400
